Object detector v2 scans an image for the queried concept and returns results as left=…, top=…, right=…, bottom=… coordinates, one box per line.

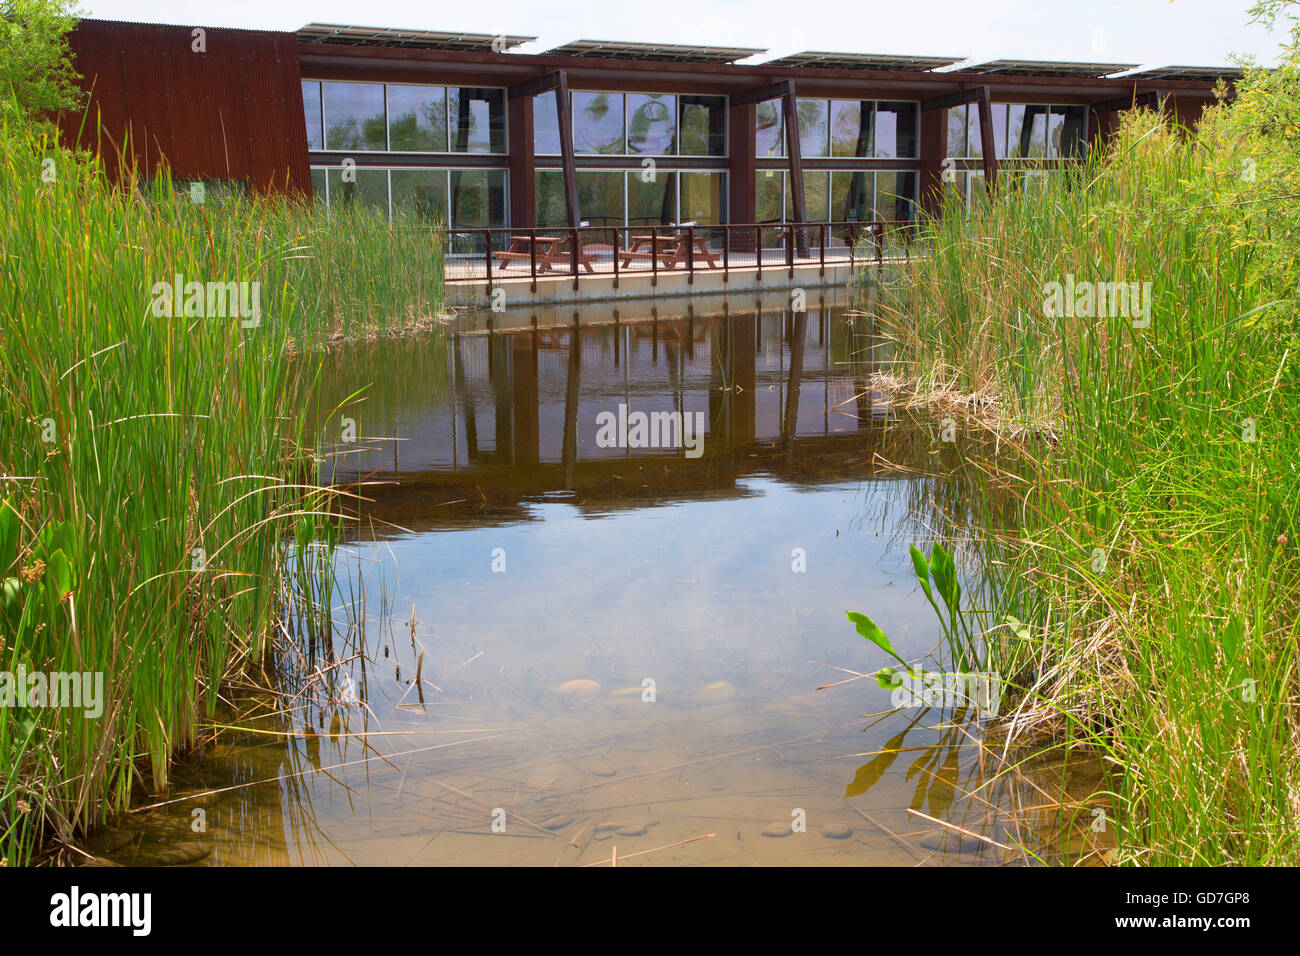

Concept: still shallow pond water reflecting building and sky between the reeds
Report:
left=91, top=293, right=1104, bottom=866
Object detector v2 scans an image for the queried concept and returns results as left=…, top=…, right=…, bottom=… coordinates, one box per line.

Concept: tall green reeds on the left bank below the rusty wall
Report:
left=0, top=115, right=442, bottom=864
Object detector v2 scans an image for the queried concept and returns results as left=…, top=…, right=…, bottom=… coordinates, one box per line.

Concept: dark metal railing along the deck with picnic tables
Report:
left=446, top=220, right=914, bottom=291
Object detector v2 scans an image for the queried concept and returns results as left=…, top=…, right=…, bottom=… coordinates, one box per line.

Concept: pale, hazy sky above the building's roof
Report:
left=79, top=0, right=1283, bottom=66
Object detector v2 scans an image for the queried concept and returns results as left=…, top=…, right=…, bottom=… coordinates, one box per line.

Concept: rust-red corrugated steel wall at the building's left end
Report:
left=60, top=20, right=311, bottom=194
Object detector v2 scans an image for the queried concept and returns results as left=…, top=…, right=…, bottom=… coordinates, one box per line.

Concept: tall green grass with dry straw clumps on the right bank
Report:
left=885, top=111, right=1300, bottom=865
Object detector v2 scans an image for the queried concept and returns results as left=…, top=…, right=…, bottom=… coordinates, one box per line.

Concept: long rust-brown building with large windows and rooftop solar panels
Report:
left=61, top=20, right=1239, bottom=229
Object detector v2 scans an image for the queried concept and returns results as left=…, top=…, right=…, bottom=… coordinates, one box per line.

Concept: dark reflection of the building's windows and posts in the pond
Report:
left=327, top=310, right=884, bottom=488
